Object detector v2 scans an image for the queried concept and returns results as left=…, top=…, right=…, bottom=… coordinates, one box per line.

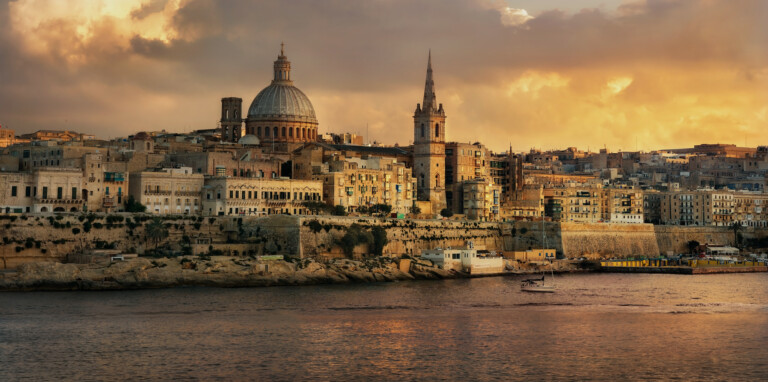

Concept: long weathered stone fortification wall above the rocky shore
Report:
left=0, top=214, right=768, bottom=269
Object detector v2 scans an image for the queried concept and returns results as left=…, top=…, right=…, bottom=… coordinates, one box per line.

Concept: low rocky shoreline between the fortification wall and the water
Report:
left=0, top=256, right=588, bottom=291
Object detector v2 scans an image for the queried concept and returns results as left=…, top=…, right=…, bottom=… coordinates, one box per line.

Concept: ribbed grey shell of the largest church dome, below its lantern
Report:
left=248, top=81, right=317, bottom=123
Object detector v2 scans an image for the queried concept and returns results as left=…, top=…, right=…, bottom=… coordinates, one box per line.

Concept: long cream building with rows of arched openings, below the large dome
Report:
left=202, top=176, right=323, bottom=215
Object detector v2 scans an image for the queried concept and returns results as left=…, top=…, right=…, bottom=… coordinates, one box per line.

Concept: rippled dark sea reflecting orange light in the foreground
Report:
left=0, top=273, right=768, bottom=381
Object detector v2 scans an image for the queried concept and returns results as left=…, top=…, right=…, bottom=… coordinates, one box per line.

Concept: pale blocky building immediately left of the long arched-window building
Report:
left=129, top=167, right=203, bottom=215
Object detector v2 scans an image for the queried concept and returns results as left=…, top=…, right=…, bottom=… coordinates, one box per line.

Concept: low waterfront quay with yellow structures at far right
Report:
left=598, top=259, right=768, bottom=275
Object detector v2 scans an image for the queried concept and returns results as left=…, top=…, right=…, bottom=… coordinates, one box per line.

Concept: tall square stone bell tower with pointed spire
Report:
left=413, top=51, right=446, bottom=213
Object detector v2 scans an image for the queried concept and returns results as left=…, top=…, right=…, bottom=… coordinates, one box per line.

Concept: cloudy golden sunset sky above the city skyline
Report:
left=0, top=0, right=768, bottom=151
